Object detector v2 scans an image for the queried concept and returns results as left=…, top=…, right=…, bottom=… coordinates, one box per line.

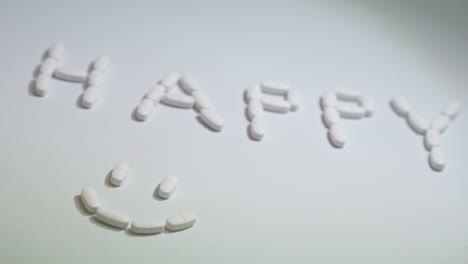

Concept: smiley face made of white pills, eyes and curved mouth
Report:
left=81, top=162, right=197, bottom=235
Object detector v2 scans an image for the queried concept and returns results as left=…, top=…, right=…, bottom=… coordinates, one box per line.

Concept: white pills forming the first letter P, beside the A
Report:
left=245, top=81, right=301, bottom=141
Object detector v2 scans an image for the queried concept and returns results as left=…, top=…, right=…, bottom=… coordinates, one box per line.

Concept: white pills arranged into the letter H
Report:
left=34, top=43, right=110, bottom=108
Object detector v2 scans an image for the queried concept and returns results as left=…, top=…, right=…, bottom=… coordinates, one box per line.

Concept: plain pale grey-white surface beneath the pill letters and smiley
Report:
left=0, top=1, right=468, bottom=264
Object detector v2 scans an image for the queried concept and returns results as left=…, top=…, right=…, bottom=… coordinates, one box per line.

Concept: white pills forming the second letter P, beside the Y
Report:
left=320, top=88, right=375, bottom=148
